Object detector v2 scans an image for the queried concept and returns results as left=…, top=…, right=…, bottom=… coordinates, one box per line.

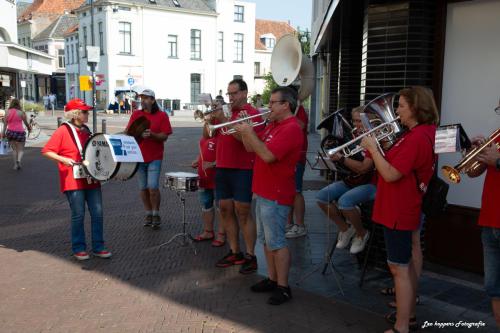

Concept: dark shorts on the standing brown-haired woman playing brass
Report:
left=384, top=227, right=413, bottom=266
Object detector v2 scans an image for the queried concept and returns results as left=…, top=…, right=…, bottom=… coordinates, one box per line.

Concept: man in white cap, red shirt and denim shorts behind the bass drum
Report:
left=127, top=89, right=172, bottom=229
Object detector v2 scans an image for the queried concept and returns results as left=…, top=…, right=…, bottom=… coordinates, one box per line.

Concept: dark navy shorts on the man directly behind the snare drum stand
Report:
left=215, top=168, right=252, bottom=203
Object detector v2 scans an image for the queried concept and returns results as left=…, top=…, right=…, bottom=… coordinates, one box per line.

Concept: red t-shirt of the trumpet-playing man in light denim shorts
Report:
left=252, top=117, right=303, bottom=206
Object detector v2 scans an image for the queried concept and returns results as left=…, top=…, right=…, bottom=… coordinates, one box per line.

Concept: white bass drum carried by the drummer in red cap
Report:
left=82, top=133, right=139, bottom=181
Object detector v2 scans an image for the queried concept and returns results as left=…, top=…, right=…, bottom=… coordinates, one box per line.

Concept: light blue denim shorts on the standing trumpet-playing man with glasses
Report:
left=255, top=196, right=291, bottom=251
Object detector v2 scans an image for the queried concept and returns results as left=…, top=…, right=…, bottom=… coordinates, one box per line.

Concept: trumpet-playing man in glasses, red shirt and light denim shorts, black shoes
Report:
left=235, top=87, right=303, bottom=305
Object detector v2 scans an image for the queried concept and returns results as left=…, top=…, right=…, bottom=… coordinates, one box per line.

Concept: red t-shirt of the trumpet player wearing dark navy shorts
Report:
left=216, top=104, right=262, bottom=170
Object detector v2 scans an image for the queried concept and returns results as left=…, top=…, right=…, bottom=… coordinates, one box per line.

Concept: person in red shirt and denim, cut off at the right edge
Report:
left=473, top=127, right=500, bottom=328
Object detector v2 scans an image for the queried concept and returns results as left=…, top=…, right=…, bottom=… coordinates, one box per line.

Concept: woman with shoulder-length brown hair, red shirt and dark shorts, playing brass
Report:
left=361, top=86, right=439, bottom=333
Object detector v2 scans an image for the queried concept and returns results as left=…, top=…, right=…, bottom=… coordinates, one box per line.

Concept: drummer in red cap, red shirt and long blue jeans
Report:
left=42, top=98, right=111, bottom=260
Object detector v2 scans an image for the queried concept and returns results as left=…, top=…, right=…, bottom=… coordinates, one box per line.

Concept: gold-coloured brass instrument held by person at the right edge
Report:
left=441, top=128, right=500, bottom=184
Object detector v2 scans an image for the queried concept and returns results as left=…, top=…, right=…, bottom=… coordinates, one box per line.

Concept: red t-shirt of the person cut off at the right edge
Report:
left=479, top=137, right=500, bottom=228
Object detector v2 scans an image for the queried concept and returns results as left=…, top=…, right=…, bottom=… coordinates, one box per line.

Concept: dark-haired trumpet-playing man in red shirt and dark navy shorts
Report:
left=203, top=79, right=262, bottom=274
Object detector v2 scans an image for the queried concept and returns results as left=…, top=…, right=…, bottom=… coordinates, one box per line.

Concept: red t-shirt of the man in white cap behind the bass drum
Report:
left=127, top=110, right=172, bottom=163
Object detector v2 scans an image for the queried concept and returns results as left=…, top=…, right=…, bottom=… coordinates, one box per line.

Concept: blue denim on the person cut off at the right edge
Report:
left=481, top=227, right=500, bottom=298
